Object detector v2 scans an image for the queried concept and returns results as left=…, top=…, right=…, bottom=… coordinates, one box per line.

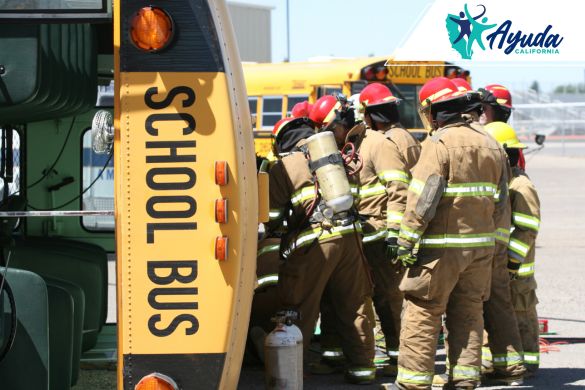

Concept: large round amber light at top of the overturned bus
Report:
left=130, top=6, right=174, bottom=52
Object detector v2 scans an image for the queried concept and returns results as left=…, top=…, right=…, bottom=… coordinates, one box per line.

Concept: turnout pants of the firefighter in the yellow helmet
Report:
left=510, top=276, right=540, bottom=374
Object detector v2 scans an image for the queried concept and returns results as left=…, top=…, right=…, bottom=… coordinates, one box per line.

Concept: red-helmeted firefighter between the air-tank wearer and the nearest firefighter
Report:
left=360, top=83, right=421, bottom=375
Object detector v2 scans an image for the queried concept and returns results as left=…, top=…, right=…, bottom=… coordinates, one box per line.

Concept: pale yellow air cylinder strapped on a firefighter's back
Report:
left=307, top=131, right=353, bottom=214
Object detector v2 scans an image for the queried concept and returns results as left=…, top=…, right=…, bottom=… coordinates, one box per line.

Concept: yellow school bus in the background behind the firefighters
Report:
left=243, top=57, right=470, bottom=156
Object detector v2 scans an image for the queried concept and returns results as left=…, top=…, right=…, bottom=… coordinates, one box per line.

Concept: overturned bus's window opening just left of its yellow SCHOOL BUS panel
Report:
left=81, top=129, right=114, bottom=231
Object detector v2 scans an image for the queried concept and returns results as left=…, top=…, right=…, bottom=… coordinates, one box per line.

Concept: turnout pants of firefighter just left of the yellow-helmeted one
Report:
left=483, top=242, right=525, bottom=376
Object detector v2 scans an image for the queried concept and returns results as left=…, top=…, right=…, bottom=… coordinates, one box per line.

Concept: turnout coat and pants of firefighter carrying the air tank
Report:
left=268, top=106, right=375, bottom=383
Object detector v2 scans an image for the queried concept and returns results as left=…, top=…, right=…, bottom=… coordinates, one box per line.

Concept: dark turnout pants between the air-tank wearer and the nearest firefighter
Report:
left=364, top=241, right=404, bottom=364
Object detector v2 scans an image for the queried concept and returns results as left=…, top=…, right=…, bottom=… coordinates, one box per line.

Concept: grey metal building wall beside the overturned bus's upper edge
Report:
left=228, top=3, right=272, bottom=62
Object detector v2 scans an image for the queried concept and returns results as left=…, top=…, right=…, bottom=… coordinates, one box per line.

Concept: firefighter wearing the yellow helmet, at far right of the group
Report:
left=486, top=122, right=540, bottom=376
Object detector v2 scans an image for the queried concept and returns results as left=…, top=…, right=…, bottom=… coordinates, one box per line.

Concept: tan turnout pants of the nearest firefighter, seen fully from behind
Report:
left=396, top=247, right=494, bottom=389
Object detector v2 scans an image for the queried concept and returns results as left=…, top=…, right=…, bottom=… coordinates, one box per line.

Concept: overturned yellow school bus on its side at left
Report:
left=0, top=0, right=260, bottom=390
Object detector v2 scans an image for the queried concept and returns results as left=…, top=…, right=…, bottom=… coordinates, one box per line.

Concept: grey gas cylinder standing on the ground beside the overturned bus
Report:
left=264, top=315, right=303, bottom=390
